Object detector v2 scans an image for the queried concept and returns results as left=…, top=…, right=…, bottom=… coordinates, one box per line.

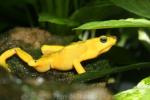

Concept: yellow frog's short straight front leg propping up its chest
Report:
left=73, top=60, right=86, bottom=74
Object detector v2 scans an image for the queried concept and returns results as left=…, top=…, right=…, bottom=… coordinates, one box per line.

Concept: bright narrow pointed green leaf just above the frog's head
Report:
left=74, top=18, right=150, bottom=30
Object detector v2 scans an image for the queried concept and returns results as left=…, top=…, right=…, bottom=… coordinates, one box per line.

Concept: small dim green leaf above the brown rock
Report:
left=39, top=14, right=79, bottom=26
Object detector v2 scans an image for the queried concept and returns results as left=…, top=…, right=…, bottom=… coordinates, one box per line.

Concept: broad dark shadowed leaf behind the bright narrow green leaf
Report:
left=71, top=0, right=128, bottom=23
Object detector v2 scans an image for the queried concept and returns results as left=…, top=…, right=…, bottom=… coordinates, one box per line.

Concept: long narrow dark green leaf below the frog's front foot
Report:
left=72, top=62, right=150, bottom=82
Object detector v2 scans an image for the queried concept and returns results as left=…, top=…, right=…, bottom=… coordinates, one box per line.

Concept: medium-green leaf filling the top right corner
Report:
left=111, top=0, right=150, bottom=18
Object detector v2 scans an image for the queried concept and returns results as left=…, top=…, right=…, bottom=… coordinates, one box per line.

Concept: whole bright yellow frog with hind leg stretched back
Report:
left=0, top=35, right=116, bottom=74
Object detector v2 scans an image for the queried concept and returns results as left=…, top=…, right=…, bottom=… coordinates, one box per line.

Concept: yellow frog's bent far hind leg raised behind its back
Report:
left=41, top=45, right=64, bottom=55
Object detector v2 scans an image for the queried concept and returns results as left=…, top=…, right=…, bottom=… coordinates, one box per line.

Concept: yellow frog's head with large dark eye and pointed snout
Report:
left=96, top=35, right=117, bottom=54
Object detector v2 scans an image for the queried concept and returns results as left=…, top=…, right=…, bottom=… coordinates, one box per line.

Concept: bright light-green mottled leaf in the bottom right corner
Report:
left=114, top=77, right=150, bottom=100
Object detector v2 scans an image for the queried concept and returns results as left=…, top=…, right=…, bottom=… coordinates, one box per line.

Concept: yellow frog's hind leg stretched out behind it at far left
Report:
left=0, top=48, right=36, bottom=71
